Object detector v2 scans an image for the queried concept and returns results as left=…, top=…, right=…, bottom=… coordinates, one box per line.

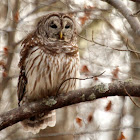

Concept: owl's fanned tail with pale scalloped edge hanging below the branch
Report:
left=21, top=110, right=56, bottom=134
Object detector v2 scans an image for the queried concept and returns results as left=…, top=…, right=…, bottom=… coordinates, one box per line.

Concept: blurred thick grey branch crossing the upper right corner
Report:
left=103, top=0, right=140, bottom=36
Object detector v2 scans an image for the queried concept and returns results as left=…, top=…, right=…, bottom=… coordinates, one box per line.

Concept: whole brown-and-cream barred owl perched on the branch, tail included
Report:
left=18, top=13, right=79, bottom=133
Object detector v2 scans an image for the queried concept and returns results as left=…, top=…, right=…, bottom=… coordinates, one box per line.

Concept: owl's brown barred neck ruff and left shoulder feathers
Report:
left=19, top=33, right=78, bottom=67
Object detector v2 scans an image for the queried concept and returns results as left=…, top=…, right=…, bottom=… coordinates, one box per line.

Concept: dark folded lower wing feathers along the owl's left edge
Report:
left=17, top=68, right=27, bottom=106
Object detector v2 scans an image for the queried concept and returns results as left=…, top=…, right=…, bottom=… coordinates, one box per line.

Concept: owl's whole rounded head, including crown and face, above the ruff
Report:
left=37, top=13, right=76, bottom=42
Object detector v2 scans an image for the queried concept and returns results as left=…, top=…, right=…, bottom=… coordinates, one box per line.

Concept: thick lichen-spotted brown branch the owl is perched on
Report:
left=0, top=82, right=140, bottom=130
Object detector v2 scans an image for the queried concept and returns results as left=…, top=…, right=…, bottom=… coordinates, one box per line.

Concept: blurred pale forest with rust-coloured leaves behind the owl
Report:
left=0, top=0, right=140, bottom=140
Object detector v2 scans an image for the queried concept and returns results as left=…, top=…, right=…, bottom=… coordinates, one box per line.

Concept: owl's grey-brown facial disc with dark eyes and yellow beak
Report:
left=45, top=15, right=74, bottom=42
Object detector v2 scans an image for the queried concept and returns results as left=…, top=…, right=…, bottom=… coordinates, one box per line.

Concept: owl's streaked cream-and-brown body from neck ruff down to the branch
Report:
left=18, top=35, right=79, bottom=102
